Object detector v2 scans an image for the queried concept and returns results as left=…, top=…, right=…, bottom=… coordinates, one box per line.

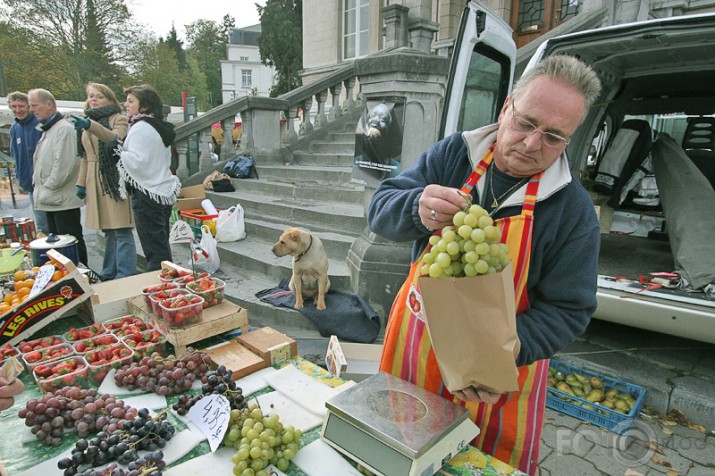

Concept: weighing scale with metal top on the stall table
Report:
left=320, top=372, right=479, bottom=476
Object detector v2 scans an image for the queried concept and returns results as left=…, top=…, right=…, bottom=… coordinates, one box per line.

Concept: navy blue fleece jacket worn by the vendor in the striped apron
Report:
left=368, top=133, right=600, bottom=366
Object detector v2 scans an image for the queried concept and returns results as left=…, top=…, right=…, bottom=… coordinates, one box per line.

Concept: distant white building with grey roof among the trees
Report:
left=221, top=24, right=275, bottom=103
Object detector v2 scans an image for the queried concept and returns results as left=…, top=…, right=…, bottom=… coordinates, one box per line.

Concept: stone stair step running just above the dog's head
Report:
left=204, top=184, right=367, bottom=236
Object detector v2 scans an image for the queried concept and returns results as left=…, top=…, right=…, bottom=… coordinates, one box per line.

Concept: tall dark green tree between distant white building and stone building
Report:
left=256, top=0, right=303, bottom=97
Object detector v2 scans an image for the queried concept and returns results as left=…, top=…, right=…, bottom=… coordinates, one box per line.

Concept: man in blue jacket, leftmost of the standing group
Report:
left=7, top=91, right=49, bottom=234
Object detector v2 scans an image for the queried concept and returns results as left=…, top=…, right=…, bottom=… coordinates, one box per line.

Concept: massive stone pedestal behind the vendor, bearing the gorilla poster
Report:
left=348, top=50, right=449, bottom=318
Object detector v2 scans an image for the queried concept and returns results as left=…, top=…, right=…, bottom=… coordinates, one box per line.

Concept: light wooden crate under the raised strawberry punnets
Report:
left=128, top=296, right=248, bottom=355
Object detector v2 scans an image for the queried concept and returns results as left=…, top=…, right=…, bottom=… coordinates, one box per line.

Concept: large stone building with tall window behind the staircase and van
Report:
left=303, top=0, right=715, bottom=84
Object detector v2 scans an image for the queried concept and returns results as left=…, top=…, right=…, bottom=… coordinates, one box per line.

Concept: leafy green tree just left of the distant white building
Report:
left=186, top=19, right=227, bottom=107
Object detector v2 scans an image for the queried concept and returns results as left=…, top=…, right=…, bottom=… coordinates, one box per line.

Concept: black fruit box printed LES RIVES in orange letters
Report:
left=0, top=250, right=92, bottom=346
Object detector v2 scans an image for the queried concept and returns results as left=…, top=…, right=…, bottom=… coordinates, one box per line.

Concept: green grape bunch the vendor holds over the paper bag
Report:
left=420, top=205, right=510, bottom=278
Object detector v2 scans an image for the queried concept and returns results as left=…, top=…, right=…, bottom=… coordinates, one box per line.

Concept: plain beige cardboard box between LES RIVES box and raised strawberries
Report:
left=92, top=271, right=161, bottom=322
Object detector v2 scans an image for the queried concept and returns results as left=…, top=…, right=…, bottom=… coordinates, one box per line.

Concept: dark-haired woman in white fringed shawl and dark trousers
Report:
left=117, top=84, right=181, bottom=271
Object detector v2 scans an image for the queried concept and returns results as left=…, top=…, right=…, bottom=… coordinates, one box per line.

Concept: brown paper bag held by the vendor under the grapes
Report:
left=418, top=264, right=520, bottom=393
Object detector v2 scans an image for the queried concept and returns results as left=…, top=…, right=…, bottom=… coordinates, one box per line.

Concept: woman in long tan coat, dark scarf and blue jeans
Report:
left=74, top=83, right=137, bottom=281
